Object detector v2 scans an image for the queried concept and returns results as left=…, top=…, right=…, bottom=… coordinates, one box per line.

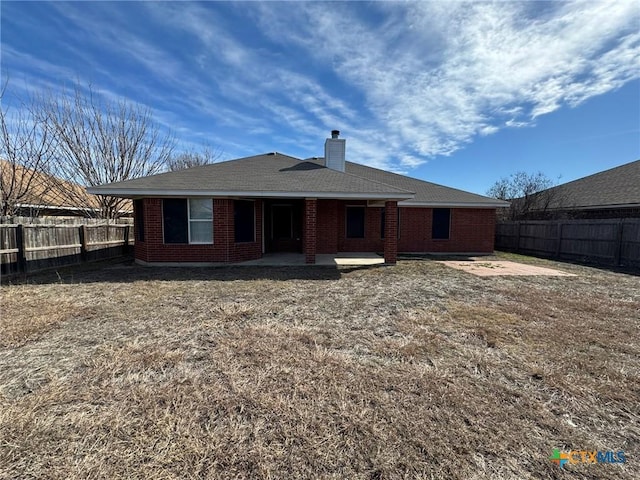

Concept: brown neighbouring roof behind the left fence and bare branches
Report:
left=0, top=160, right=132, bottom=212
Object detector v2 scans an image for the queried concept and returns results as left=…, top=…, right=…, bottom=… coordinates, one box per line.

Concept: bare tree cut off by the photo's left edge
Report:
left=0, top=81, right=55, bottom=216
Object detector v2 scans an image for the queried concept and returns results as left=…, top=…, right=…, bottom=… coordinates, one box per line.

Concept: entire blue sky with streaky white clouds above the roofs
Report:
left=0, top=0, right=640, bottom=193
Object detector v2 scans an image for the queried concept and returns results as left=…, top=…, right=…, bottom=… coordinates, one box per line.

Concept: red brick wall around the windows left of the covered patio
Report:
left=135, top=198, right=262, bottom=262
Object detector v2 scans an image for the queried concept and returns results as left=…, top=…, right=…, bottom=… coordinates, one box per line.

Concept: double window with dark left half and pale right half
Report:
left=162, top=198, right=213, bottom=243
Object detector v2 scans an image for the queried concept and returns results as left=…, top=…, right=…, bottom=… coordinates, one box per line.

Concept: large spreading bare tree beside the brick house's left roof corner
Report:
left=39, top=85, right=173, bottom=219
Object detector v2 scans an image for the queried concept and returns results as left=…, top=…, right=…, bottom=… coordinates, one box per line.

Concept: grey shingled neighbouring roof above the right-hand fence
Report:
left=540, top=160, right=640, bottom=210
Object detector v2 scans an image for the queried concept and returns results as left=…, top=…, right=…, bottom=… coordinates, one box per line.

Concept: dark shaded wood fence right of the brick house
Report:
left=496, top=218, right=640, bottom=268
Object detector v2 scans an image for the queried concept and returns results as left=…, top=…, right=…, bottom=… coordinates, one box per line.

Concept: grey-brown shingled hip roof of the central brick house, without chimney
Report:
left=88, top=152, right=508, bottom=208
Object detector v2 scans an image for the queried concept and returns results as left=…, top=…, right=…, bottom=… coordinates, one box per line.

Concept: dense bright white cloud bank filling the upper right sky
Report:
left=256, top=1, right=640, bottom=164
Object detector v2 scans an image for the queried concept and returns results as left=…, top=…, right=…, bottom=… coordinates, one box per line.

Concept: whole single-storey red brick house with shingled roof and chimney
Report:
left=88, top=130, right=508, bottom=264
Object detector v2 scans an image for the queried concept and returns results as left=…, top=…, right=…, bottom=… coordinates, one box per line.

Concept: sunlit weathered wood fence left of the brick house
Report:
left=0, top=224, right=133, bottom=275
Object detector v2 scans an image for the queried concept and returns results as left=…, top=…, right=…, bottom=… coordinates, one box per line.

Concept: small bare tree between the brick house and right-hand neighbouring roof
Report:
left=487, top=172, right=556, bottom=220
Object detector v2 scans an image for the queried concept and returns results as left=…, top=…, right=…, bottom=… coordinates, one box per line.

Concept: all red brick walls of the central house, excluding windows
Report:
left=135, top=198, right=495, bottom=262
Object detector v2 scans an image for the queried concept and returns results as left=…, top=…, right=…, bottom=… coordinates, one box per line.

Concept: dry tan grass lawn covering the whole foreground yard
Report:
left=0, top=257, right=640, bottom=479
